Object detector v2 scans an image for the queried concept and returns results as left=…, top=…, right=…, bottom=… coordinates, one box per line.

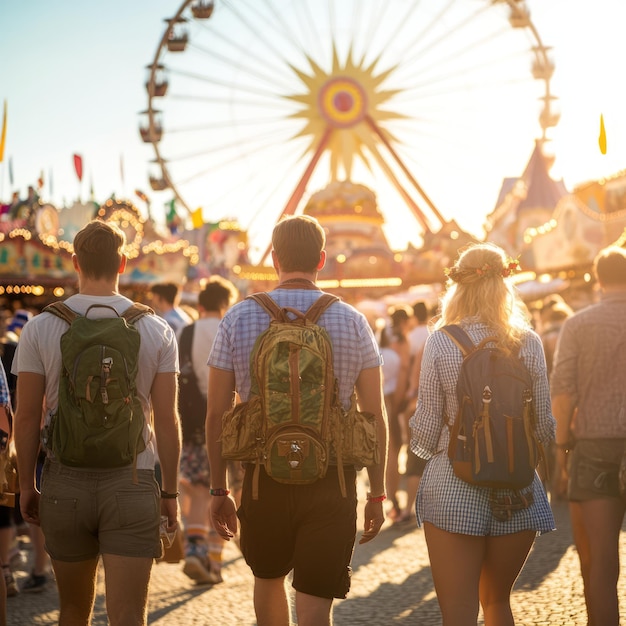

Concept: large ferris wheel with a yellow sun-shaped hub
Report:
left=140, top=0, right=559, bottom=258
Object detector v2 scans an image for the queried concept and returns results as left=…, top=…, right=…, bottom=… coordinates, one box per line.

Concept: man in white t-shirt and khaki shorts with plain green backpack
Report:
left=13, top=220, right=180, bottom=626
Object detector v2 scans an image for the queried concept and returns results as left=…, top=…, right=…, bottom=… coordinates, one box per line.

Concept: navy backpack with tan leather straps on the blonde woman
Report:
left=441, top=324, right=543, bottom=490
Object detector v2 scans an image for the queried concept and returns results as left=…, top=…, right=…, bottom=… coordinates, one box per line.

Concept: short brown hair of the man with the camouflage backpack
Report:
left=272, top=215, right=326, bottom=272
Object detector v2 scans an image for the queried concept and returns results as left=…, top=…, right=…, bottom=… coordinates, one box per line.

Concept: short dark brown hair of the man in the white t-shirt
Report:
left=74, top=220, right=126, bottom=279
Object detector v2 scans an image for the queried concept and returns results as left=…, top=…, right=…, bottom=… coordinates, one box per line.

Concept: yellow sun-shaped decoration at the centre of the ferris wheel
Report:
left=284, top=44, right=406, bottom=180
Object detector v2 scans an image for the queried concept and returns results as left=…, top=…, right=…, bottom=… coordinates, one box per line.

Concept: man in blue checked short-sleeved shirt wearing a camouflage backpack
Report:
left=207, top=216, right=387, bottom=626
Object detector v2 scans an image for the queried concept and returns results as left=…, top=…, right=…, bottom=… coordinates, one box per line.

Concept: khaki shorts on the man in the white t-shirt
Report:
left=39, top=461, right=161, bottom=562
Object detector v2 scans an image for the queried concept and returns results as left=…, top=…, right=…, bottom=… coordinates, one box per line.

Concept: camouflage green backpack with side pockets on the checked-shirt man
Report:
left=221, top=293, right=378, bottom=499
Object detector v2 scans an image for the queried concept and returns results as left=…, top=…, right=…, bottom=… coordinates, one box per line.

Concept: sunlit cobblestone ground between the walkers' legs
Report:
left=8, top=490, right=626, bottom=626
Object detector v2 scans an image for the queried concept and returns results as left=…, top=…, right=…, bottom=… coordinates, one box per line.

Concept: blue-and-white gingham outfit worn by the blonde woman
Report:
left=410, top=320, right=556, bottom=536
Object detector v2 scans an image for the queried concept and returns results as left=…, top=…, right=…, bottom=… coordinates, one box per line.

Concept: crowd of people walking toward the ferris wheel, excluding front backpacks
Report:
left=0, top=216, right=626, bottom=626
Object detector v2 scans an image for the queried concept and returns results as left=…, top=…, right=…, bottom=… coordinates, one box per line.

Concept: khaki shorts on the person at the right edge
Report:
left=567, top=439, right=626, bottom=502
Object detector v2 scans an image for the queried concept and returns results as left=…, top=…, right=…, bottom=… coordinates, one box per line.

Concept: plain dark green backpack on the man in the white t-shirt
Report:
left=44, top=302, right=154, bottom=468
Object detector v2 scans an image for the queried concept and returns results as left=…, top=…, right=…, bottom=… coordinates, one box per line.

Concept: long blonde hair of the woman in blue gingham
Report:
left=435, top=243, right=530, bottom=349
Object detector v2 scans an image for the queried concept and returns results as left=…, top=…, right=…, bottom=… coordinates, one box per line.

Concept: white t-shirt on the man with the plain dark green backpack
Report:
left=11, top=294, right=178, bottom=469
